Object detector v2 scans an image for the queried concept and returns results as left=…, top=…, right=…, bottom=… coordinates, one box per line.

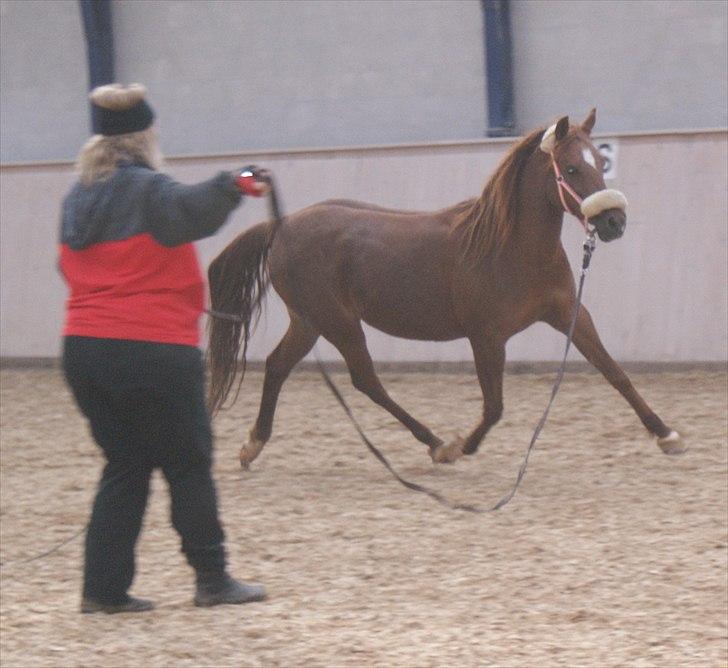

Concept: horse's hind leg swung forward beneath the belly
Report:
left=322, top=321, right=442, bottom=452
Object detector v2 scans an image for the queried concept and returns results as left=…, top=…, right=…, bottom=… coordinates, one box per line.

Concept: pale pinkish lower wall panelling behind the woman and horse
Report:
left=0, top=132, right=728, bottom=362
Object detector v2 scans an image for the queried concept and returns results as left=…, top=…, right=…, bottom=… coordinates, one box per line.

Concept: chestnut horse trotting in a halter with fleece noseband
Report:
left=208, top=110, right=683, bottom=468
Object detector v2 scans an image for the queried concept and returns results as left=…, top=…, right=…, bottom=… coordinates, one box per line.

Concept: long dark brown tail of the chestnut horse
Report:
left=207, top=221, right=277, bottom=413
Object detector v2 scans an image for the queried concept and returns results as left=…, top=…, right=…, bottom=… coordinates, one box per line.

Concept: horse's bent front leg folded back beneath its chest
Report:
left=431, top=335, right=506, bottom=463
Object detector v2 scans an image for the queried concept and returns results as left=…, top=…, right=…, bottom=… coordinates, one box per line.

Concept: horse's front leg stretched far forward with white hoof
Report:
left=547, top=305, right=686, bottom=455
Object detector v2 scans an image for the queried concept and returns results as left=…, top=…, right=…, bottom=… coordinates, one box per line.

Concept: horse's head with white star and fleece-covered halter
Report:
left=541, top=109, right=627, bottom=241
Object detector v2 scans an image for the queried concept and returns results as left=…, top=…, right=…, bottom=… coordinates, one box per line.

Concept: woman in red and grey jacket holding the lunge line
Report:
left=59, top=84, right=267, bottom=613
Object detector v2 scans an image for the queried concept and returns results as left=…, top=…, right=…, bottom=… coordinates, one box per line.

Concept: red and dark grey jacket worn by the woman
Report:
left=59, top=163, right=241, bottom=346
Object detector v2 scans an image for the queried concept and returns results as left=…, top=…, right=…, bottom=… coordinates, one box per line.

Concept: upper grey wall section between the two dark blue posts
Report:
left=114, top=0, right=485, bottom=153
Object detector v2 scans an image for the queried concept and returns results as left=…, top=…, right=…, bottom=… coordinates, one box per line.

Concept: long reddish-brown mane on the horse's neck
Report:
left=454, top=128, right=544, bottom=259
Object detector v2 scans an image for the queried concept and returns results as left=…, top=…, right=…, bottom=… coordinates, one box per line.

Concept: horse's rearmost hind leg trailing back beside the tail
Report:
left=240, top=312, right=319, bottom=468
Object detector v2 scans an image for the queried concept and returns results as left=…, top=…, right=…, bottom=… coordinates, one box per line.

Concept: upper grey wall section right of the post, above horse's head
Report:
left=511, top=0, right=728, bottom=132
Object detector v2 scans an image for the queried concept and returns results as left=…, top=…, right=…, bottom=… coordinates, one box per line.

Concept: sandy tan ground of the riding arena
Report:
left=0, top=369, right=728, bottom=668
